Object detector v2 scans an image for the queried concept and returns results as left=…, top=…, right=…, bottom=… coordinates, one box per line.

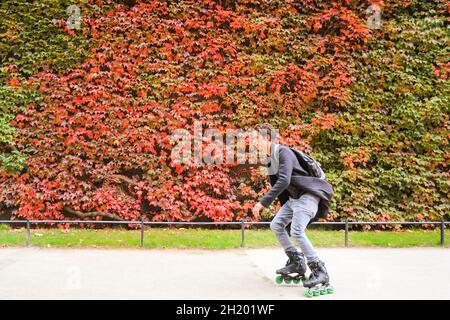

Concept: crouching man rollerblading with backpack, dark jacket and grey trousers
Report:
left=252, top=124, right=333, bottom=297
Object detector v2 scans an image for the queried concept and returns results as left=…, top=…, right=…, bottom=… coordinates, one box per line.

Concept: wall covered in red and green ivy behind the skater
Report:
left=0, top=0, right=450, bottom=221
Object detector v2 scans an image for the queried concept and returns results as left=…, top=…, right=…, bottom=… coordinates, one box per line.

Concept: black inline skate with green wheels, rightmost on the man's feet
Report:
left=303, top=261, right=334, bottom=298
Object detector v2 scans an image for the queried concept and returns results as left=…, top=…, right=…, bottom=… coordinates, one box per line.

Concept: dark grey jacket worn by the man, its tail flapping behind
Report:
left=260, top=144, right=333, bottom=220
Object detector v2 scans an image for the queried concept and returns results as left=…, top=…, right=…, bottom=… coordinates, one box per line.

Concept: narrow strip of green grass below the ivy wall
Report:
left=0, top=225, right=450, bottom=249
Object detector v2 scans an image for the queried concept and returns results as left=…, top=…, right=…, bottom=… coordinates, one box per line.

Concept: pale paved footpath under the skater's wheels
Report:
left=0, top=248, right=450, bottom=299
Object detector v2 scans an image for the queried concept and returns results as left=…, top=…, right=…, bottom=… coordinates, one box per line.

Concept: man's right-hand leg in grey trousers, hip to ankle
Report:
left=291, top=194, right=320, bottom=262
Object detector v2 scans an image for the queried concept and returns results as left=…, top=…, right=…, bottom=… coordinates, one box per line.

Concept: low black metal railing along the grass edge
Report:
left=0, top=220, right=450, bottom=247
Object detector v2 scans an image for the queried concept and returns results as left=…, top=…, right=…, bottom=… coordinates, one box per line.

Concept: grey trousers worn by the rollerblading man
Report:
left=270, top=193, right=320, bottom=262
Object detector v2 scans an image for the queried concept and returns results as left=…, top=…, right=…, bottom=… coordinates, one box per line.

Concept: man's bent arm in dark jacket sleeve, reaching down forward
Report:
left=259, top=148, right=294, bottom=208
